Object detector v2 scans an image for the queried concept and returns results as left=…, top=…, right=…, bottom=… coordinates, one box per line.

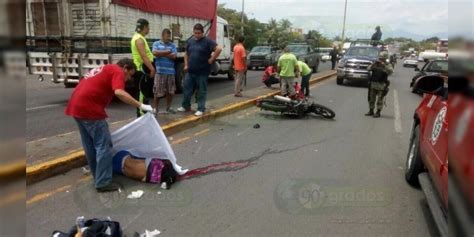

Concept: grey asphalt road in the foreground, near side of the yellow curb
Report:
left=26, top=64, right=437, bottom=236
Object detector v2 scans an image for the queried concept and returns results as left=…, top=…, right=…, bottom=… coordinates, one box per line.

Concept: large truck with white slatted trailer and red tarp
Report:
left=26, top=0, right=234, bottom=92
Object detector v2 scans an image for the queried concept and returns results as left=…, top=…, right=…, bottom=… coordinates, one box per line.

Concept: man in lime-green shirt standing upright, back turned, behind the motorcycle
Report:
left=278, top=47, right=300, bottom=97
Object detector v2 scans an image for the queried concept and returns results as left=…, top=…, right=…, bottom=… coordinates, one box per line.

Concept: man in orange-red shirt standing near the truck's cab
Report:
left=234, top=36, right=247, bottom=97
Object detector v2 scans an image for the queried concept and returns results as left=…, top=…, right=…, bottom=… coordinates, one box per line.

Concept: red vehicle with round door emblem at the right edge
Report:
left=405, top=76, right=474, bottom=236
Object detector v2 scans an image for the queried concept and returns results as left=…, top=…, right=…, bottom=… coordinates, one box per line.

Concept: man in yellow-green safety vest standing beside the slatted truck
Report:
left=130, top=19, right=155, bottom=117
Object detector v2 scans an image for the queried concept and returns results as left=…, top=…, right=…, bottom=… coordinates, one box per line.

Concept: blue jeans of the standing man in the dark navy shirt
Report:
left=181, top=73, right=209, bottom=112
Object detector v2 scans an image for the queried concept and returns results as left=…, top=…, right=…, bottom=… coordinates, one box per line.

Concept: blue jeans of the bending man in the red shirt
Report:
left=75, top=118, right=112, bottom=188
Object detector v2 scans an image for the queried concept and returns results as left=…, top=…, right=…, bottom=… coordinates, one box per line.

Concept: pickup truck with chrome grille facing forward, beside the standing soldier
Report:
left=336, top=46, right=381, bottom=85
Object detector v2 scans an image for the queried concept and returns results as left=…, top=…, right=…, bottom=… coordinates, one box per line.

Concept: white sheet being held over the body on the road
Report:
left=112, top=113, right=188, bottom=175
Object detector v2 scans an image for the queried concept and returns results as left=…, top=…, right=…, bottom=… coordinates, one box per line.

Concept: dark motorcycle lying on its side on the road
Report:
left=256, top=95, right=336, bottom=119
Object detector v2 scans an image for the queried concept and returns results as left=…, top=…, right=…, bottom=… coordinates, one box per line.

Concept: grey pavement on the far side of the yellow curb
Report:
left=26, top=63, right=331, bottom=141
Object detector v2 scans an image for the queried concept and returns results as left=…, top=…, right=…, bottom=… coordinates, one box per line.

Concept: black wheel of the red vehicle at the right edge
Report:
left=405, top=125, right=423, bottom=187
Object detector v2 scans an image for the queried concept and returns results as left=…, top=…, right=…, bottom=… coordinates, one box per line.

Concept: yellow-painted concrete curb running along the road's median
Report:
left=23, top=72, right=336, bottom=185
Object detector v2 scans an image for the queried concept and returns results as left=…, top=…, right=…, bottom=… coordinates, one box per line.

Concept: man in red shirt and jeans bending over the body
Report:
left=65, top=58, right=153, bottom=192
